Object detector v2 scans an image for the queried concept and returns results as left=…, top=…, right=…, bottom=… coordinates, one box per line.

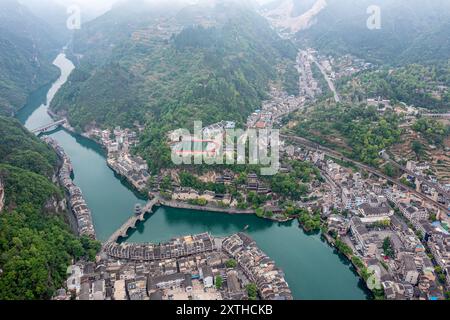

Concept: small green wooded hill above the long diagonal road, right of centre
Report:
left=294, top=103, right=402, bottom=166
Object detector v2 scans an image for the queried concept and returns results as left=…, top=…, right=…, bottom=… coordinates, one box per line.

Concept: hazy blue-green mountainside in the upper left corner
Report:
left=0, top=0, right=62, bottom=115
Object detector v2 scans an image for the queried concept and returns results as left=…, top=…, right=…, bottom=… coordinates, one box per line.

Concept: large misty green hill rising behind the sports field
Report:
left=52, top=0, right=296, bottom=130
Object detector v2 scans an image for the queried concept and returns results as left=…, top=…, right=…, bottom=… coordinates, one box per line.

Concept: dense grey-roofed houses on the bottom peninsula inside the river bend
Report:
left=55, top=233, right=292, bottom=300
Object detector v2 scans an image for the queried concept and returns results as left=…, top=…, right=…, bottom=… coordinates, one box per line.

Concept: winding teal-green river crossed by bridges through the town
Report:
left=17, top=54, right=369, bottom=300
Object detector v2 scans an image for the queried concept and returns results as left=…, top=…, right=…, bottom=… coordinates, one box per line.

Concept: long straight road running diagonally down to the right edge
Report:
left=280, top=135, right=449, bottom=214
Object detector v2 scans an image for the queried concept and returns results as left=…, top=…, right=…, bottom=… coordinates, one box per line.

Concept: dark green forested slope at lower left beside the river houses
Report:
left=0, top=117, right=98, bottom=300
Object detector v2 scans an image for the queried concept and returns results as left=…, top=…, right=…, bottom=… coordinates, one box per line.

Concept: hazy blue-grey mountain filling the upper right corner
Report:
left=293, top=0, right=450, bottom=64
